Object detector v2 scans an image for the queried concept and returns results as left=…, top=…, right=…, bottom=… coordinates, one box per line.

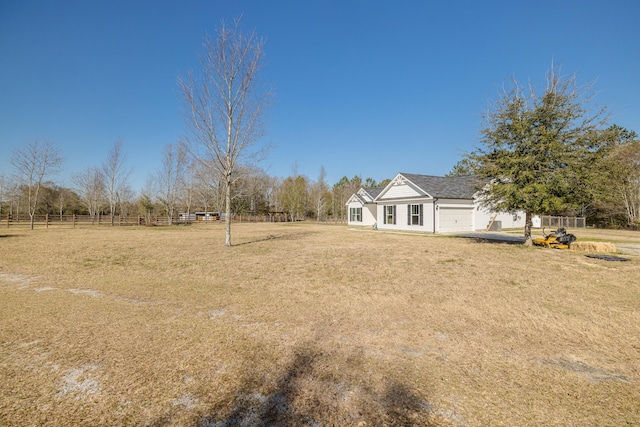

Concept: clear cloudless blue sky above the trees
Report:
left=0, top=0, right=640, bottom=190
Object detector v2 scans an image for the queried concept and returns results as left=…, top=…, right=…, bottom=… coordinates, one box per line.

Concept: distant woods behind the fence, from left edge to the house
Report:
left=0, top=140, right=390, bottom=227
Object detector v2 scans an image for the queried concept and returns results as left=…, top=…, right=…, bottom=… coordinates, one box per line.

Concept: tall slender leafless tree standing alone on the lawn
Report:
left=179, top=19, right=271, bottom=246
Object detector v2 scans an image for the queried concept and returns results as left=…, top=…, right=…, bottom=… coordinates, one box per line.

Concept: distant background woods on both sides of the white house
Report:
left=0, top=115, right=640, bottom=234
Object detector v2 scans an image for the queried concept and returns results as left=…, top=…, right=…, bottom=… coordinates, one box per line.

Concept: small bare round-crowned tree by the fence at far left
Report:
left=10, top=139, right=63, bottom=230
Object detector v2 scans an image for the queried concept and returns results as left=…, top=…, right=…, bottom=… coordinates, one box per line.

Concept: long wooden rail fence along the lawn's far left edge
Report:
left=2, top=214, right=346, bottom=228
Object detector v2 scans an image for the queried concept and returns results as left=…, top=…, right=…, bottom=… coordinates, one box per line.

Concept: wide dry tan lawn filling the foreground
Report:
left=0, top=224, right=640, bottom=427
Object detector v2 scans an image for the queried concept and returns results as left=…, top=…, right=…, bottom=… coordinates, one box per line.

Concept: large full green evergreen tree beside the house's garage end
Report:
left=465, top=67, right=606, bottom=245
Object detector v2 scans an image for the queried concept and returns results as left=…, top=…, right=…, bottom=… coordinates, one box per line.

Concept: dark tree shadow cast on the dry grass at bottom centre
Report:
left=195, top=346, right=440, bottom=427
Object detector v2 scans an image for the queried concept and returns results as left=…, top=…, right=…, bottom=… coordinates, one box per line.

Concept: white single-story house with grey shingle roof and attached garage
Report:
left=347, top=173, right=524, bottom=233
